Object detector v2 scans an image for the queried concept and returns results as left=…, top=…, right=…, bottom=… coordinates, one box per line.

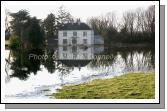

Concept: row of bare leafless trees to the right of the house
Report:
left=88, top=6, right=155, bottom=45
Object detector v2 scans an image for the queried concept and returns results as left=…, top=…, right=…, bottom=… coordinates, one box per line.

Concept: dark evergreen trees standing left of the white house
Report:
left=5, top=6, right=73, bottom=50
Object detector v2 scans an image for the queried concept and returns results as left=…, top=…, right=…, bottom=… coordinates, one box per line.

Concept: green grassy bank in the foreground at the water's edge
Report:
left=51, top=73, right=155, bottom=99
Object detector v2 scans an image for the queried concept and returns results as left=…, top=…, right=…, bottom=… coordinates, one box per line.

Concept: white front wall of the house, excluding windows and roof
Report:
left=58, top=30, right=94, bottom=45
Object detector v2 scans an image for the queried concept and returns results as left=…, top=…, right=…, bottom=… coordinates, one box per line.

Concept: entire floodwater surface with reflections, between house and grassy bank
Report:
left=6, top=45, right=155, bottom=98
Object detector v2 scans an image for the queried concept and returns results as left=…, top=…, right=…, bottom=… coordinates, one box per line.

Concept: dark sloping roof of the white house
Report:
left=60, top=23, right=91, bottom=30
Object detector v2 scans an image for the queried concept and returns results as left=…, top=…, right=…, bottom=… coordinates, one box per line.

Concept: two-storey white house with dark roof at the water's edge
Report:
left=58, top=22, right=94, bottom=46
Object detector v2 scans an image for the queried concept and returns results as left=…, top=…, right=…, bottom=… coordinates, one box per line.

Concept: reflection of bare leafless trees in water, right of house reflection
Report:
left=90, top=47, right=155, bottom=75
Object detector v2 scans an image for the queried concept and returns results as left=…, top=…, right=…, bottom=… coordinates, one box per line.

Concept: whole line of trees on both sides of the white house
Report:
left=5, top=6, right=155, bottom=49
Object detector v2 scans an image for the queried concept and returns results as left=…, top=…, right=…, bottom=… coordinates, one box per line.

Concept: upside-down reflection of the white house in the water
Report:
left=58, top=45, right=94, bottom=70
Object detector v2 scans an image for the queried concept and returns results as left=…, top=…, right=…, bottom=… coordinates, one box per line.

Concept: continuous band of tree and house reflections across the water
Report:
left=6, top=47, right=155, bottom=81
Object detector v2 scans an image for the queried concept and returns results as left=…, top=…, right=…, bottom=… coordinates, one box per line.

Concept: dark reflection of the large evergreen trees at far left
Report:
left=10, top=49, right=44, bottom=80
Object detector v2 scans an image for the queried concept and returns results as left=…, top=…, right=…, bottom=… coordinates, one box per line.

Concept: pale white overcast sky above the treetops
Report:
left=5, top=4, right=150, bottom=22
